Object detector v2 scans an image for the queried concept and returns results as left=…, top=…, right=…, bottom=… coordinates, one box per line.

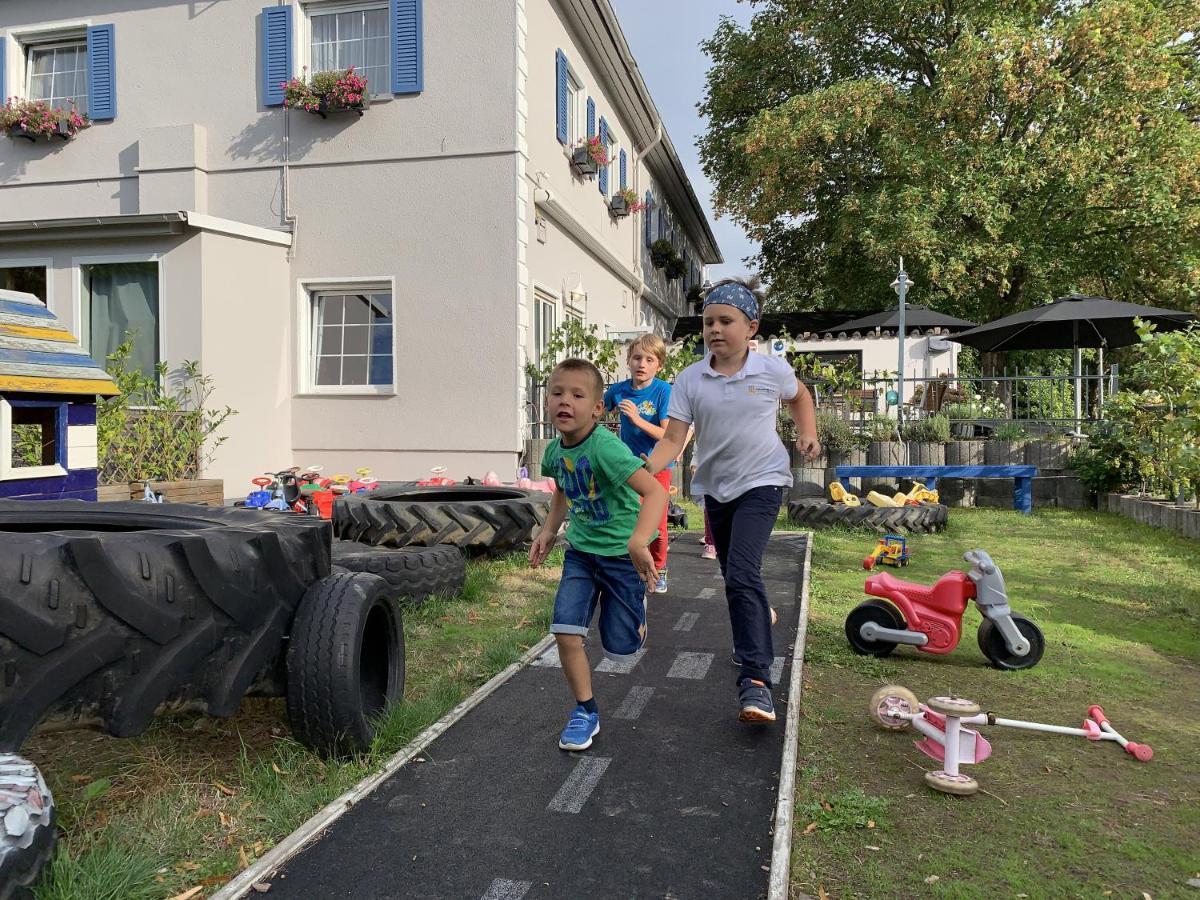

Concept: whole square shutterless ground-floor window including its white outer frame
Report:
left=301, top=280, right=396, bottom=394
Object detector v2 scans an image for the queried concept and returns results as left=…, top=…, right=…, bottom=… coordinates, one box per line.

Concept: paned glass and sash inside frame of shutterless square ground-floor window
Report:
left=311, top=290, right=395, bottom=388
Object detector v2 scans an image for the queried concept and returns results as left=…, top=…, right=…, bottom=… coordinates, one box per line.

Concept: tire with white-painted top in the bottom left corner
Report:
left=0, top=754, right=58, bottom=900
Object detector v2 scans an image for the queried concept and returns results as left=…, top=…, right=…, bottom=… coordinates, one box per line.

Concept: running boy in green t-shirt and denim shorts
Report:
left=529, top=359, right=667, bottom=750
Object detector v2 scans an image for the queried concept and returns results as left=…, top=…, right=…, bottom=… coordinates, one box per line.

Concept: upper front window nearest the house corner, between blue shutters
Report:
left=308, top=5, right=391, bottom=96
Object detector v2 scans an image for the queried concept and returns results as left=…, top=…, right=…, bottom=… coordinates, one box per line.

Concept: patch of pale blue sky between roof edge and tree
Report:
left=611, top=0, right=757, bottom=281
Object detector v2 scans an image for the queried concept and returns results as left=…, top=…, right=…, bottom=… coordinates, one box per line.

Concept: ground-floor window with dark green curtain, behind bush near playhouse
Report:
left=79, top=262, right=162, bottom=378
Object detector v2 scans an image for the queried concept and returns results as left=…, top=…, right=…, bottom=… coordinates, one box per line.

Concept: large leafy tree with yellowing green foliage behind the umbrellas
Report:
left=700, top=0, right=1200, bottom=322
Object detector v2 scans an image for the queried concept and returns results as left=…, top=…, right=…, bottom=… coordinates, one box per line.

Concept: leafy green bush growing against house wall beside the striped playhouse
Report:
left=96, top=338, right=236, bottom=485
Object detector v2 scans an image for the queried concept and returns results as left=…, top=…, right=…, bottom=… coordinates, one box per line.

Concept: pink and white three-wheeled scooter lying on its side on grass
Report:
left=869, top=684, right=1154, bottom=797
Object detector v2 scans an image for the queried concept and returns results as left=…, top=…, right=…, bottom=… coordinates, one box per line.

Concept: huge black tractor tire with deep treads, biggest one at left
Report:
left=0, top=500, right=331, bottom=751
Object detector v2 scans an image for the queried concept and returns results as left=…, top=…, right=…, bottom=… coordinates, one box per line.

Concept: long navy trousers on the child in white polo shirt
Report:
left=704, top=487, right=784, bottom=685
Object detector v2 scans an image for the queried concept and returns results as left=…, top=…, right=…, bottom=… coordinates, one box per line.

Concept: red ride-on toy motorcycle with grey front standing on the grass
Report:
left=846, top=550, right=1045, bottom=670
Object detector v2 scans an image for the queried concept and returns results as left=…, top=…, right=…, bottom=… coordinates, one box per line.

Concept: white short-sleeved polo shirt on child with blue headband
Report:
left=670, top=353, right=797, bottom=503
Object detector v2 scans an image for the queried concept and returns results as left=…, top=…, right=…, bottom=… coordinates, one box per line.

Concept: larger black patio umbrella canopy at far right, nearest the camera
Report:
left=954, top=294, right=1195, bottom=350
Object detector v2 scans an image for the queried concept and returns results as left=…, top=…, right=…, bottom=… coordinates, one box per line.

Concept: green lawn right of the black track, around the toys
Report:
left=792, top=509, right=1200, bottom=900
